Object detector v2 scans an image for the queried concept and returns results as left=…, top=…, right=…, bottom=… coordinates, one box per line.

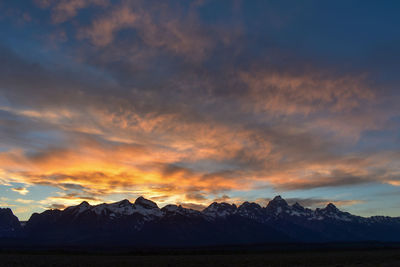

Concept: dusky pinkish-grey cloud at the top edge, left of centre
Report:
left=78, top=1, right=217, bottom=61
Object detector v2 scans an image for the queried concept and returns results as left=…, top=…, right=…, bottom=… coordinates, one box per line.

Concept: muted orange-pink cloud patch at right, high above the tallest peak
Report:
left=240, top=70, right=374, bottom=114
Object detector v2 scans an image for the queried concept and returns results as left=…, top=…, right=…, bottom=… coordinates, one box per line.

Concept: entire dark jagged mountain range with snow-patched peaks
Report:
left=0, top=196, right=400, bottom=247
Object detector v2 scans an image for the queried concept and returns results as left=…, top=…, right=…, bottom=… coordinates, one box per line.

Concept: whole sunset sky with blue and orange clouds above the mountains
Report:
left=0, top=0, right=400, bottom=220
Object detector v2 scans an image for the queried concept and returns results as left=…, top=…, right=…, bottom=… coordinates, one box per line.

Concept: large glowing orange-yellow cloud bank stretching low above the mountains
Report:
left=0, top=99, right=396, bottom=208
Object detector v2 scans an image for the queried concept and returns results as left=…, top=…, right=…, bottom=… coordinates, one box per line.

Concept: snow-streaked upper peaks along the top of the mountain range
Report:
left=25, top=196, right=400, bottom=228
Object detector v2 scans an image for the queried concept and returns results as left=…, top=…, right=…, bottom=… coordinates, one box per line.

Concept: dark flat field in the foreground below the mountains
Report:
left=0, top=250, right=400, bottom=267
